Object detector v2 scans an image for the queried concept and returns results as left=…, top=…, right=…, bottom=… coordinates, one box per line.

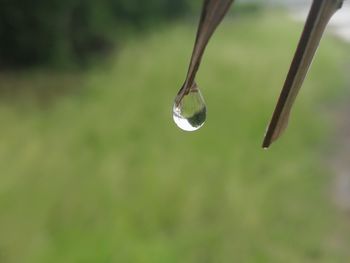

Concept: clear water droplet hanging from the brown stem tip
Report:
left=173, top=87, right=207, bottom=131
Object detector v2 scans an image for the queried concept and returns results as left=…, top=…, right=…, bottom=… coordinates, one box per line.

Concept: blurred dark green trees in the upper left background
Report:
left=0, top=0, right=191, bottom=67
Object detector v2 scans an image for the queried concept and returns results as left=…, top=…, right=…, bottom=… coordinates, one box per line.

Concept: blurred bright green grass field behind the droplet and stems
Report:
left=0, top=13, right=350, bottom=263
